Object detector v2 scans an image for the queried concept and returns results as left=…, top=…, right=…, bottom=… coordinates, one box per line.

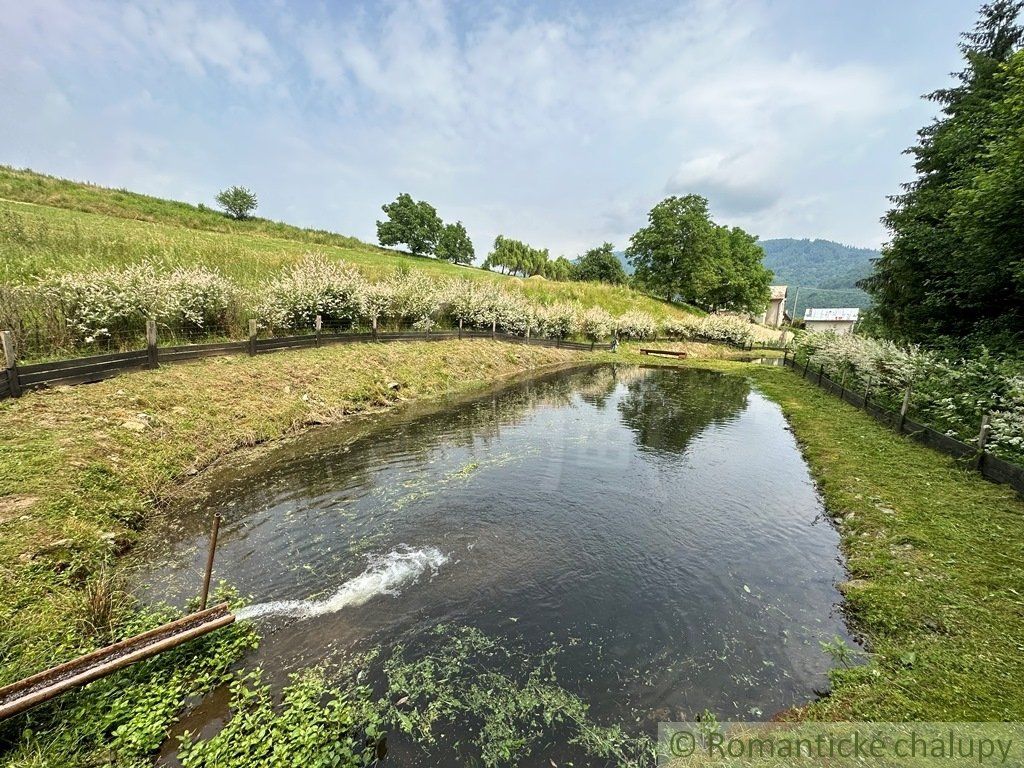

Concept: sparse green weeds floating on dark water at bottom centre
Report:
left=384, top=626, right=654, bottom=767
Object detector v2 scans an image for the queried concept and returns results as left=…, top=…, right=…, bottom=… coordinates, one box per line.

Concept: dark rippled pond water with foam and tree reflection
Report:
left=144, top=366, right=848, bottom=765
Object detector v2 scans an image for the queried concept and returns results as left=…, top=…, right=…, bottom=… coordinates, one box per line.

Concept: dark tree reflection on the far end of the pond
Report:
left=618, top=371, right=751, bottom=454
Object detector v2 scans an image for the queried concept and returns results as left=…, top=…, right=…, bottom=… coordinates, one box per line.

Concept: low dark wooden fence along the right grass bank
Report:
left=782, top=351, right=1024, bottom=495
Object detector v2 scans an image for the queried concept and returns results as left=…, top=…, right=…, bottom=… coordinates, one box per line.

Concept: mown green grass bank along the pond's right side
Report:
left=606, top=345, right=1024, bottom=722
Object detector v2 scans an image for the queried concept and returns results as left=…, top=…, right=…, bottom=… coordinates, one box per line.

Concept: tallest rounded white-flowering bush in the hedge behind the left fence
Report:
left=258, top=255, right=365, bottom=329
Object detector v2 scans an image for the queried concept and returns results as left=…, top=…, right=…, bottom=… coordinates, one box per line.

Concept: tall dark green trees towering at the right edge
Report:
left=861, top=0, right=1024, bottom=341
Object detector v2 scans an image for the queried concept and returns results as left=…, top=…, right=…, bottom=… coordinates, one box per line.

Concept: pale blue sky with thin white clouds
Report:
left=0, top=0, right=977, bottom=257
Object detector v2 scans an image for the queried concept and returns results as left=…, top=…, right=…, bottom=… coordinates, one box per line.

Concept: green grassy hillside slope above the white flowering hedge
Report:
left=0, top=166, right=695, bottom=318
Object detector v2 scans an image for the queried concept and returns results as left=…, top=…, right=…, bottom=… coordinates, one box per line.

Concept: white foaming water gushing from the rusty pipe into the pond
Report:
left=234, top=547, right=449, bottom=620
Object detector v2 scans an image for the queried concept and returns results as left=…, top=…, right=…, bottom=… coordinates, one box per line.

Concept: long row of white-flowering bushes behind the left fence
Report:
left=9, top=255, right=770, bottom=354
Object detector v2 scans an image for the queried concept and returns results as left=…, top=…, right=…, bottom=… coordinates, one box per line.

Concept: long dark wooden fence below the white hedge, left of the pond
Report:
left=0, top=324, right=596, bottom=399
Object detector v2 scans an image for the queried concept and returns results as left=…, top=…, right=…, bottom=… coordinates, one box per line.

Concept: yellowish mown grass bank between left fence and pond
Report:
left=0, top=341, right=580, bottom=685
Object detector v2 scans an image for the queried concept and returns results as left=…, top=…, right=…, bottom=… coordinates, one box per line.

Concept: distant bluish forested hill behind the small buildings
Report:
left=761, top=238, right=881, bottom=317
